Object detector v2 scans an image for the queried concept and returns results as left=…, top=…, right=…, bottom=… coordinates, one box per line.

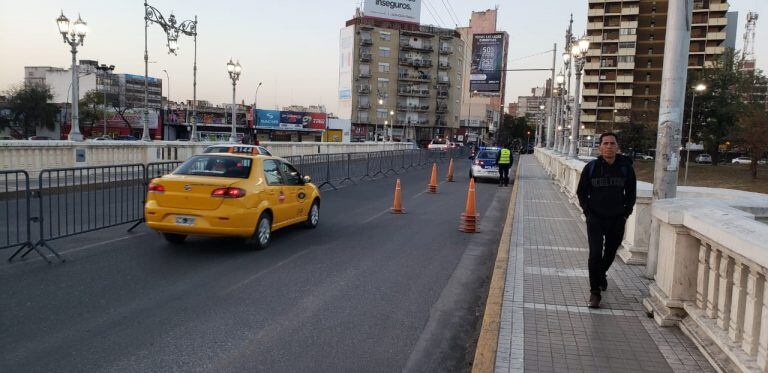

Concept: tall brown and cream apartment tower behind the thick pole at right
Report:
left=581, top=0, right=736, bottom=137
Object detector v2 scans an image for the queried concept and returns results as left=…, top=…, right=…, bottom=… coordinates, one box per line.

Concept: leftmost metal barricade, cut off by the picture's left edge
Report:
left=0, top=170, right=35, bottom=262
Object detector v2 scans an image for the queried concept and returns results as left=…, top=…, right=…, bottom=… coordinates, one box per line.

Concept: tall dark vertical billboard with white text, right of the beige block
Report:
left=469, top=32, right=505, bottom=93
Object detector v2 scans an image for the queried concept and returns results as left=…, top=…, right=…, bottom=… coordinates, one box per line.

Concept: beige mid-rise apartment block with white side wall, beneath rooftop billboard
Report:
left=339, top=13, right=464, bottom=143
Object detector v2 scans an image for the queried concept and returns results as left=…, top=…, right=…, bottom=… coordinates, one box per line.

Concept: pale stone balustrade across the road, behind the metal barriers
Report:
left=0, top=140, right=413, bottom=178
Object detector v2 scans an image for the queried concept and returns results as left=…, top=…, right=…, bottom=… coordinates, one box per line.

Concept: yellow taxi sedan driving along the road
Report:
left=144, top=146, right=320, bottom=249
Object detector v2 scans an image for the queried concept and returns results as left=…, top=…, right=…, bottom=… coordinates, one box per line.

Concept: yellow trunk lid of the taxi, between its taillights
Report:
left=150, top=175, right=243, bottom=210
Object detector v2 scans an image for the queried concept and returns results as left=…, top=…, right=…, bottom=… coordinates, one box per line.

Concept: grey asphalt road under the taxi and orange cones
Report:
left=0, top=160, right=511, bottom=372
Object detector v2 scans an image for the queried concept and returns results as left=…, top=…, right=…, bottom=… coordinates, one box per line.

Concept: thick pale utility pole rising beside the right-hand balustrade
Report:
left=645, top=0, right=693, bottom=278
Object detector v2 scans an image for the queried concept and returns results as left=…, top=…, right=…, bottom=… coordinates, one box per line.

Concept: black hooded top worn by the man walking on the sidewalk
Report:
left=576, top=154, right=637, bottom=219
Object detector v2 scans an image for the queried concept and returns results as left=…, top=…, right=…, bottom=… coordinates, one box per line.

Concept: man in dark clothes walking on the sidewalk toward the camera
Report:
left=576, top=133, right=637, bottom=308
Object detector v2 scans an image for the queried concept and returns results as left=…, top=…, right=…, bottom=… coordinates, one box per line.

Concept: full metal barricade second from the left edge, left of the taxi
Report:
left=31, top=164, right=147, bottom=259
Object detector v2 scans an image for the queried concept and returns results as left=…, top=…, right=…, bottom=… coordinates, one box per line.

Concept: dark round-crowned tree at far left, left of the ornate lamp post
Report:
left=0, top=83, right=59, bottom=138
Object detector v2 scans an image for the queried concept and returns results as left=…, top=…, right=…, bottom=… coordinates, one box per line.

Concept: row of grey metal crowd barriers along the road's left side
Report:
left=6, top=148, right=466, bottom=263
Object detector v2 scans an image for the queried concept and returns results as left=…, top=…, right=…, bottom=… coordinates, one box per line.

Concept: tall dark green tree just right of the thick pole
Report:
left=684, top=48, right=747, bottom=166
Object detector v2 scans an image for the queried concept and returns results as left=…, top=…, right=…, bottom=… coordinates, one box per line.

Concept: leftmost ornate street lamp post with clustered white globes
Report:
left=56, top=12, right=88, bottom=141
